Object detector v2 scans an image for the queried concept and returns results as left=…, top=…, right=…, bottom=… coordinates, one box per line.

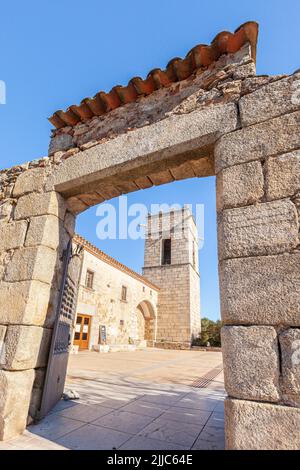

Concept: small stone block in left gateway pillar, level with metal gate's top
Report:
left=25, top=215, right=69, bottom=250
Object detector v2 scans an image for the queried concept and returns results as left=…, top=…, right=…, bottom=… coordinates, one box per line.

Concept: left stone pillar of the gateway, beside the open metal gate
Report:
left=0, top=158, right=74, bottom=439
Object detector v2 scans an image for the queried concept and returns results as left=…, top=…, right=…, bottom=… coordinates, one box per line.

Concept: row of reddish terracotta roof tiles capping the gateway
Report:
left=49, top=21, right=258, bottom=129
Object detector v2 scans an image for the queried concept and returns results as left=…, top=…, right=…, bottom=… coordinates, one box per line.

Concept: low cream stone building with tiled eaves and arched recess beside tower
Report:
left=74, top=236, right=159, bottom=351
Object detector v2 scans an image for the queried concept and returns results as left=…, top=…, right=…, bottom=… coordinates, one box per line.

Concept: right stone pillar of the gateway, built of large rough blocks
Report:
left=215, top=73, right=300, bottom=449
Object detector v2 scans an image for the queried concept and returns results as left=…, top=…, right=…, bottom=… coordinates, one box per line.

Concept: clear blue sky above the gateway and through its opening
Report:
left=0, top=0, right=300, bottom=318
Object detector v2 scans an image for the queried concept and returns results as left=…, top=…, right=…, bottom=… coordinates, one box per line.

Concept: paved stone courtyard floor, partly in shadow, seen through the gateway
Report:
left=0, top=349, right=225, bottom=450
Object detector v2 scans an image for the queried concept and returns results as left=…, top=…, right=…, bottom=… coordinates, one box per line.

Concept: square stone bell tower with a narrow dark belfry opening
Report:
left=143, top=207, right=201, bottom=348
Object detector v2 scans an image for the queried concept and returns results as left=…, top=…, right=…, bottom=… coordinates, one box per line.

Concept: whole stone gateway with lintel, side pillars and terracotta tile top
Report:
left=0, top=23, right=300, bottom=449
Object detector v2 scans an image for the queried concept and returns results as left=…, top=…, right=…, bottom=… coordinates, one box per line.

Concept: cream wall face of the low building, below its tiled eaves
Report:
left=77, top=251, right=158, bottom=349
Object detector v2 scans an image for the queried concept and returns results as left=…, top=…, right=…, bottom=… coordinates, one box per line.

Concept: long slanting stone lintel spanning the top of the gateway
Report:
left=46, top=103, right=238, bottom=192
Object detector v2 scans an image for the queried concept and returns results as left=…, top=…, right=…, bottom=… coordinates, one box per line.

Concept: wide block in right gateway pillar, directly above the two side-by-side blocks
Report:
left=220, top=252, right=300, bottom=326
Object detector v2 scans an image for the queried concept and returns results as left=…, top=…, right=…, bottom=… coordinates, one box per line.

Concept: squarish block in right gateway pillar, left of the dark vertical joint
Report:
left=222, top=326, right=280, bottom=402
